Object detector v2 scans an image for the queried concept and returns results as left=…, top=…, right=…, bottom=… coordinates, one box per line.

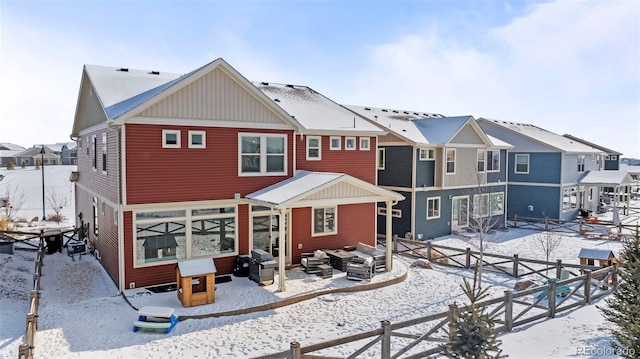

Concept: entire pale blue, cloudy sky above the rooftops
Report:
left=0, top=0, right=640, bottom=158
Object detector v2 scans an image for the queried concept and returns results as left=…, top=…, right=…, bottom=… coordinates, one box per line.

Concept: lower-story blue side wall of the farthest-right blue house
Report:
left=507, top=184, right=561, bottom=219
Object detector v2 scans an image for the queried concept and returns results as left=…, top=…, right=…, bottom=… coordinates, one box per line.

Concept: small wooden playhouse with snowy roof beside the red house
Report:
left=176, top=258, right=216, bottom=307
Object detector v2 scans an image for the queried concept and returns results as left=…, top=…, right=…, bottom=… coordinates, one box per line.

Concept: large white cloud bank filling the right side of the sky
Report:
left=345, top=1, right=640, bottom=157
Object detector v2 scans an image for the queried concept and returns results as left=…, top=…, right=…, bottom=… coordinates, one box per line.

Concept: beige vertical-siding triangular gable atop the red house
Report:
left=138, top=67, right=291, bottom=128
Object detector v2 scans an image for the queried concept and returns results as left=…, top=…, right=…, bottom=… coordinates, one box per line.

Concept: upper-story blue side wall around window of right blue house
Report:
left=509, top=152, right=562, bottom=184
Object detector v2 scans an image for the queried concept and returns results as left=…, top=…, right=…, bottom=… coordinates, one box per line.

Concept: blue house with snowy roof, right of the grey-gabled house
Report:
left=478, top=118, right=604, bottom=220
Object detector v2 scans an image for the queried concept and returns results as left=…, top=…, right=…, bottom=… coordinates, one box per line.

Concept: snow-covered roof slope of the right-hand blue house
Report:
left=480, top=118, right=602, bottom=153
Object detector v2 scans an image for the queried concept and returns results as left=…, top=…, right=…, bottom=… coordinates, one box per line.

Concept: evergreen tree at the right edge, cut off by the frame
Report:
left=598, top=232, right=640, bottom=358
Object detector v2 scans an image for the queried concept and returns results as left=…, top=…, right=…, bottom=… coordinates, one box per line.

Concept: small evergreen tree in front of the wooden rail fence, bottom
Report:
left=443, top=266, right=506, bottom=359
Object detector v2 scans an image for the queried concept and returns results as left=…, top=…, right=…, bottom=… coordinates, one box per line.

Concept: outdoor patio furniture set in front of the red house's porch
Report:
left=300, top=243, right=386, bottom=280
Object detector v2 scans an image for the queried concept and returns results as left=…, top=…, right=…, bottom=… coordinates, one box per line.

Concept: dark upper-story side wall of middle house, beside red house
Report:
left=378, top=146, right=412, bottom=188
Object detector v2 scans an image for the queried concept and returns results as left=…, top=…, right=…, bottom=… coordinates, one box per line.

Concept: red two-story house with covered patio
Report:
left=72, top=59, right=403, bottom=290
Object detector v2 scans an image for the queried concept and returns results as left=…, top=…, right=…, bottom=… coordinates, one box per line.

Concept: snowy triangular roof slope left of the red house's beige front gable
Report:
left=85, top=65, right=182, bottom=119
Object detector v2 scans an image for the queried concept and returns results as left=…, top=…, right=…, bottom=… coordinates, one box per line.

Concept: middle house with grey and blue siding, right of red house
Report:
left=345, top=106, right=509, bottom=239
